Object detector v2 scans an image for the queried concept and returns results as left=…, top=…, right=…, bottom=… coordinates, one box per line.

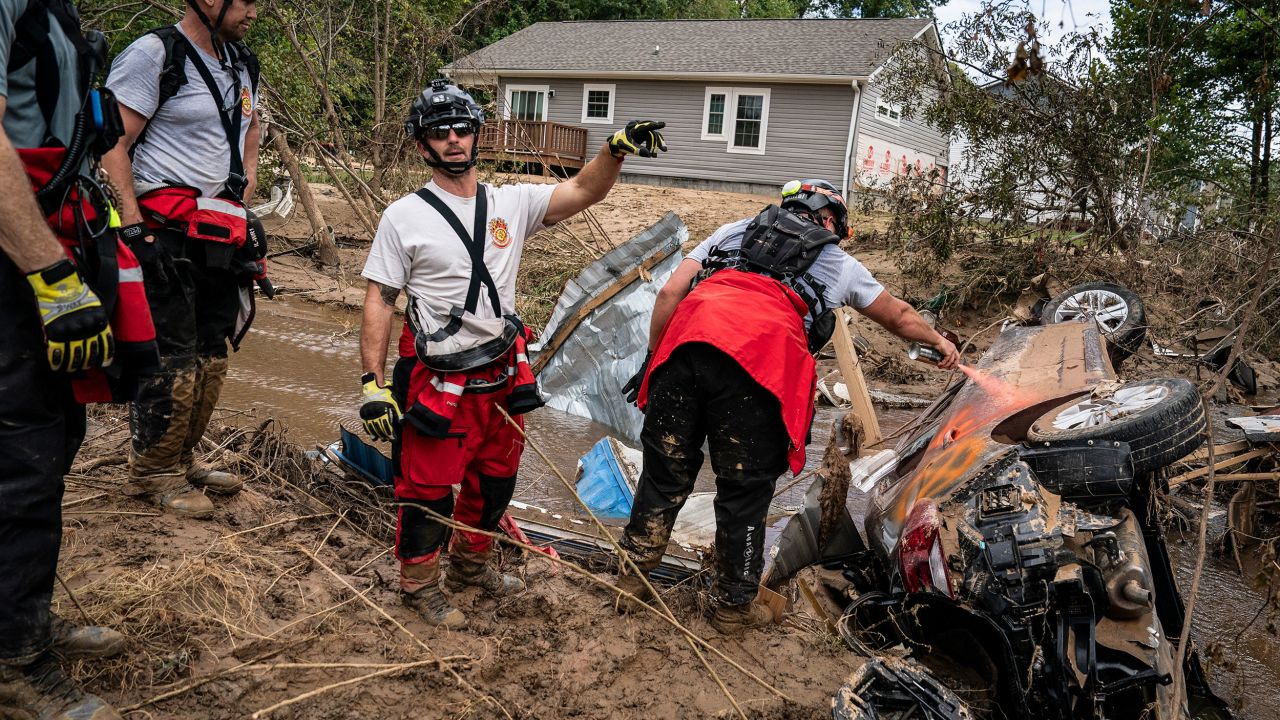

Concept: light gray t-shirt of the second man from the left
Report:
left=106, top=26, right=257, bottom=197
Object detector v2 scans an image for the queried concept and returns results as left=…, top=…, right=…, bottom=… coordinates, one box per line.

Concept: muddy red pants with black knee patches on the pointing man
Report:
left=396, top=383, right=525, bottom=562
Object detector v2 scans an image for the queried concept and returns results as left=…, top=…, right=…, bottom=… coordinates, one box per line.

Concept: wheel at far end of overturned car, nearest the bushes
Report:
left=1041, top=282, right=1147, bottom=368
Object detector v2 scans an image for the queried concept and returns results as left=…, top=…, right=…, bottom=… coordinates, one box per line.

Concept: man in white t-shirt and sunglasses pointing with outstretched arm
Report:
left=360, top=79, right=667, bottom=628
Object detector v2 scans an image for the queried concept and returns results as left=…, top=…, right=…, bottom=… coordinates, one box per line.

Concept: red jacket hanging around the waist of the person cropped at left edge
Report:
left=18, top=147, right=160, bottom=404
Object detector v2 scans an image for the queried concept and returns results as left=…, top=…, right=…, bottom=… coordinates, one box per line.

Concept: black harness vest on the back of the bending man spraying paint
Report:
left=694, top=205, right=840, bottom=354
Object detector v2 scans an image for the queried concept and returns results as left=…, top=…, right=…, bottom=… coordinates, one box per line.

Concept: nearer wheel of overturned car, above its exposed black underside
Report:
left=1027, top=378, right=1204, bottom=475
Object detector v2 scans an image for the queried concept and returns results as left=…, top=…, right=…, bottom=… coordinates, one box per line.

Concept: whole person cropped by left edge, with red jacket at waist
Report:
left=0, top=0, right=145, bottom=720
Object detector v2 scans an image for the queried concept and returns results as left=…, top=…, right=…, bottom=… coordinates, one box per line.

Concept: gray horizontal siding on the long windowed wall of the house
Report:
left=498, top=78, right=874, bottom=190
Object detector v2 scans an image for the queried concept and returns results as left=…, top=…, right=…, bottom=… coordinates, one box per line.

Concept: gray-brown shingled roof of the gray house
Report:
left=445, top=18, right=933, bottom=77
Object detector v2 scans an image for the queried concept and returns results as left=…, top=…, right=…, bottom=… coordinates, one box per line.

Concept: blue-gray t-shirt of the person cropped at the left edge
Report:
left=0, top=0, right=81, bottom=147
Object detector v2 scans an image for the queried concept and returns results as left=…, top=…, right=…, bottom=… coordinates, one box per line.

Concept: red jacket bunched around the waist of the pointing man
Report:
left=399, top=323, right=544, bottom=437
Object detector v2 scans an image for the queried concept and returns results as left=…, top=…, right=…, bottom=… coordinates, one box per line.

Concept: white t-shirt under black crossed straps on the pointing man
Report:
left=361, top=181, right=556, bottom=318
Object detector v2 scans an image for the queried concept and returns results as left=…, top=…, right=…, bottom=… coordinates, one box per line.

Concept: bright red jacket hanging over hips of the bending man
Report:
left=636, top=268, right=818, bottom=474
